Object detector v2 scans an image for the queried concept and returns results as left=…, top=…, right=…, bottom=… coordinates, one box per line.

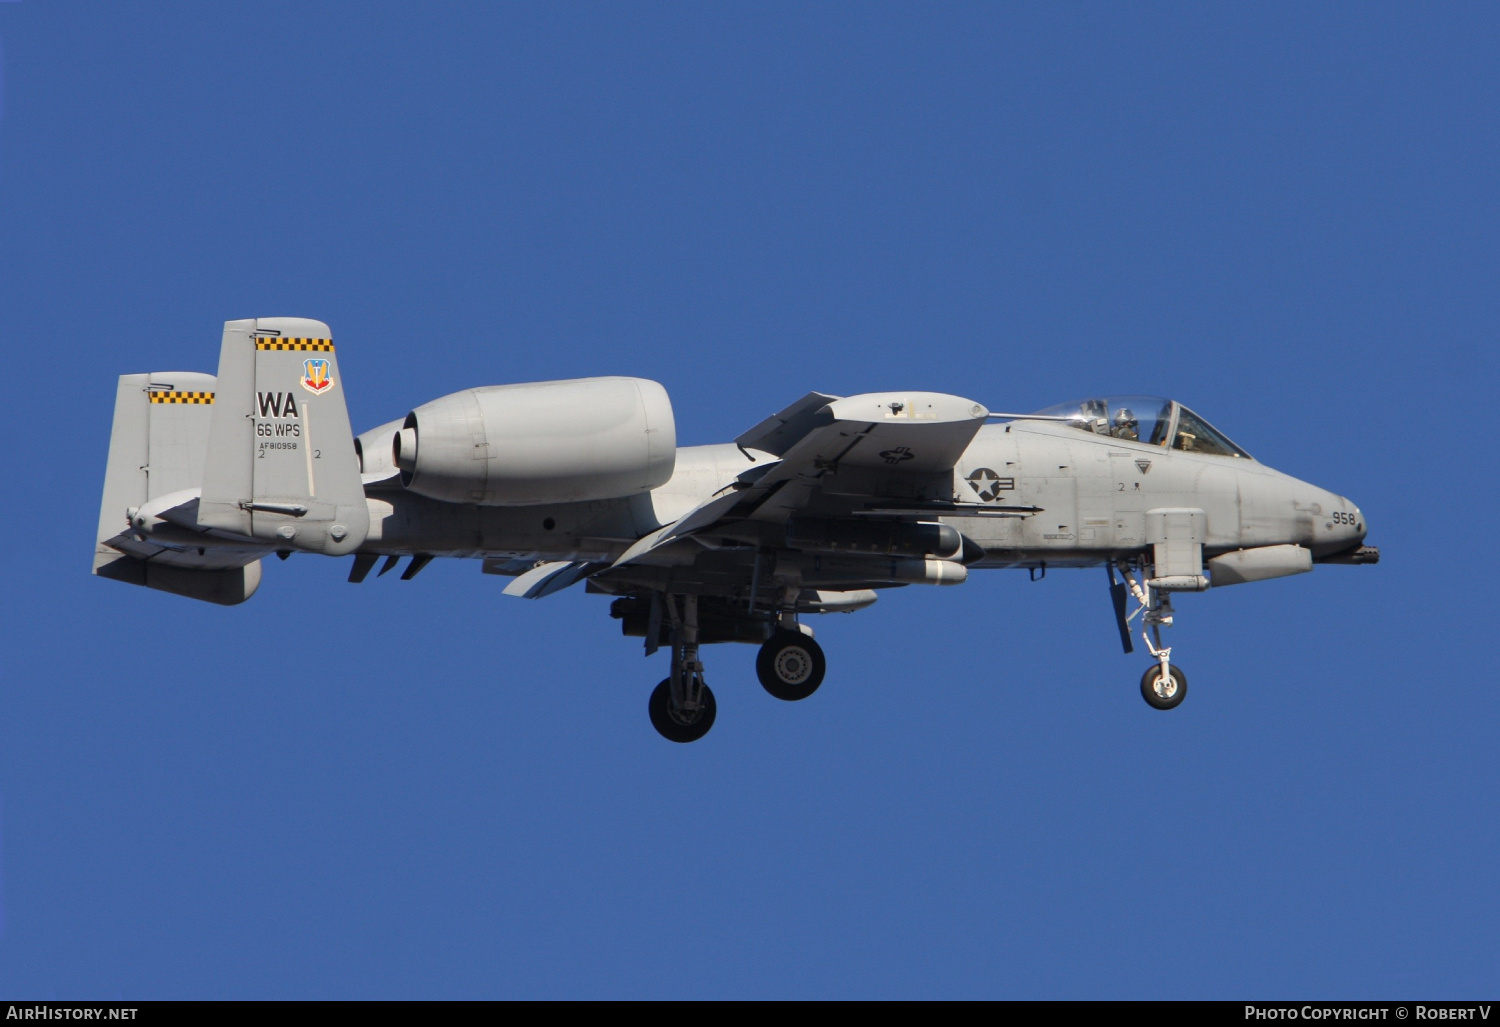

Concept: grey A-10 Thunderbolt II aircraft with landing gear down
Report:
left=93, top=318, right=1379, bottom=742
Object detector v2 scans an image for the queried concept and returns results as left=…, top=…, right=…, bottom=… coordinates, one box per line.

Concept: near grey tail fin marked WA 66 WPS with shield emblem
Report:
left=198, top=318, right=369, bottom=556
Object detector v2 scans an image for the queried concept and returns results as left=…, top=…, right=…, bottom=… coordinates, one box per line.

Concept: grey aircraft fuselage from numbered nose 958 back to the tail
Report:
left=363, top=420, right=1367, bottom=568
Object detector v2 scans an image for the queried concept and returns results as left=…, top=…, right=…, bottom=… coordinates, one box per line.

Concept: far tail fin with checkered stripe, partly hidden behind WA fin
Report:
left=93, top=372, right=266, bottom=604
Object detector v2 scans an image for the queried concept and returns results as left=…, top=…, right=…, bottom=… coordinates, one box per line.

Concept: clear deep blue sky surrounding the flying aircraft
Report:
left=0, top=3, right=1500, bottom=999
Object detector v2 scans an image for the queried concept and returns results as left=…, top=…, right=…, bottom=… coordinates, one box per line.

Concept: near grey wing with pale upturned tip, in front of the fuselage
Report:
left=606, top=393, right=995, bottom=574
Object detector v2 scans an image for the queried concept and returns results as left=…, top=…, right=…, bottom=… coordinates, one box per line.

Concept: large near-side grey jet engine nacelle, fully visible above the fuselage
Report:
left=392, top=378, right=677, bottom=507
